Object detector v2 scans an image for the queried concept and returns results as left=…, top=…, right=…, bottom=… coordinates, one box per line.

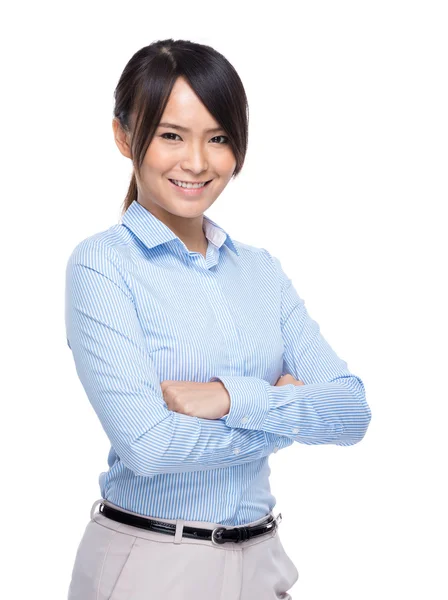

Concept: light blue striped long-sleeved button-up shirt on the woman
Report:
left=65, top=200, right=371, bottom=526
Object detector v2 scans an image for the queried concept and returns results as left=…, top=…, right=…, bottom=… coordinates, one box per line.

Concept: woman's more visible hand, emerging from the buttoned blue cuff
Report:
left=160, top=380, right=230, bottom=419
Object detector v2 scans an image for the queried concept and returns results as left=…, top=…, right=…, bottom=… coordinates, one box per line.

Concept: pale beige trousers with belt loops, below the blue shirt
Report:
left=68, top=499, right=299, bottom=600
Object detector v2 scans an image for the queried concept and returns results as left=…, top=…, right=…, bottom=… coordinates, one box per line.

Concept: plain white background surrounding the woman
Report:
left=1, top=0, right=448, bottom=600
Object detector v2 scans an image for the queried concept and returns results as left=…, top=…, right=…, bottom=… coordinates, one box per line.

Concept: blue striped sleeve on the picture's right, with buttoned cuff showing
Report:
left=210, top=248, right=371, bottom=446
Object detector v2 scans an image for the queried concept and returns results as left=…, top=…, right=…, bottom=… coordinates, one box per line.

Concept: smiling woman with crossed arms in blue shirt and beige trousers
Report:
left=66, top=39, right=370, bottom=600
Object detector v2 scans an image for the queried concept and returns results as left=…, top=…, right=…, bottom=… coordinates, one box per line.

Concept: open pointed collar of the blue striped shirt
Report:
left=121, top=200, right=240, bottom=256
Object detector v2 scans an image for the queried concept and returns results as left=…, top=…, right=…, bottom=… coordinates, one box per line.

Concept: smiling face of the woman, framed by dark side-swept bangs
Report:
left=114, top=77, right=236, bottom=218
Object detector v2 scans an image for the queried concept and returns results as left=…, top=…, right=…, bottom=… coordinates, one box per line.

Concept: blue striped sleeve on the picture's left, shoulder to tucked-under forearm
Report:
left=65, top=242, right=276, bottom=476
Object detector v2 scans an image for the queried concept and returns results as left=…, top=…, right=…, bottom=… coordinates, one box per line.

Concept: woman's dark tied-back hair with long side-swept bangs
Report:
left=113, top=38, right=249, bottom=214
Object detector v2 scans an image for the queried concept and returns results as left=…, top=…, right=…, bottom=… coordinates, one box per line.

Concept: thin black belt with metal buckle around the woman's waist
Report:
left=99, top=504, right=282, bottom=544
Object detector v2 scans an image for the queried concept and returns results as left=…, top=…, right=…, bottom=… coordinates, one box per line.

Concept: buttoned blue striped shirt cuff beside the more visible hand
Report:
left=209, top=375, right=271, bottom=429
